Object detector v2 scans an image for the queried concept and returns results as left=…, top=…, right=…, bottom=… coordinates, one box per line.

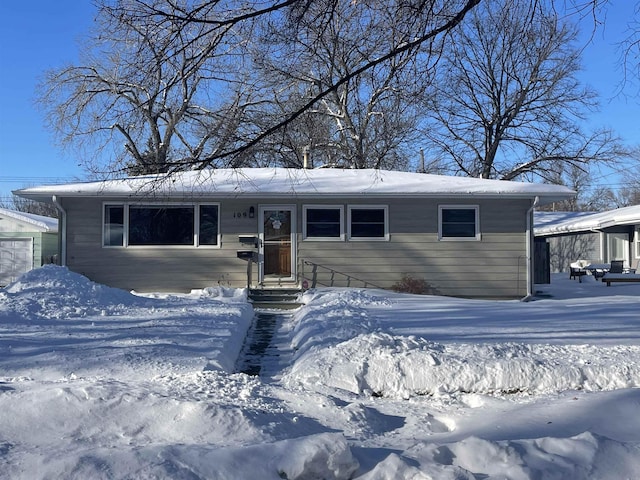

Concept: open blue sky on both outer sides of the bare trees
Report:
left=0, top=0, right=640, bottom=200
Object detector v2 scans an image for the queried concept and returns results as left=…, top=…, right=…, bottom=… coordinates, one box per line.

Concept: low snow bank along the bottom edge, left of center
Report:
left=22, top=433, right=358, bottom=480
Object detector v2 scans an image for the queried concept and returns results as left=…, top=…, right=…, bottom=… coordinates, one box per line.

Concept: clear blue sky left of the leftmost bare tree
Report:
left=0, top=0, right=96, bottom=200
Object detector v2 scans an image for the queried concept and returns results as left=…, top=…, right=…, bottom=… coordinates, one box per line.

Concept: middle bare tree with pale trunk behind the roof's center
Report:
left=245, top=1, right=446, bottom=169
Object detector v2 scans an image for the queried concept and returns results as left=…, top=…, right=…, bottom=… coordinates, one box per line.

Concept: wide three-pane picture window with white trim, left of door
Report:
left=102, top=203, right=220, bottom=247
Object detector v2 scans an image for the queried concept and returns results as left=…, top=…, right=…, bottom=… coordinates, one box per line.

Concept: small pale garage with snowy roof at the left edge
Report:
left=0, top=208, right=58, bottom=286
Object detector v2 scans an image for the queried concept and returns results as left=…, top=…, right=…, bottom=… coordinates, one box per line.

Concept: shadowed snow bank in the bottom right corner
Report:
left=400, top=432, right=640, bottom=480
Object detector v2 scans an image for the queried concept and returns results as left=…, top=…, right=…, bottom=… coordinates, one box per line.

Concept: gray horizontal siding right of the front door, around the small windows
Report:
left=299, top=199, right=529, bottom=298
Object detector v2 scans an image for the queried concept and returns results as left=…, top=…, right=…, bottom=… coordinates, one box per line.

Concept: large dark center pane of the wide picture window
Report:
left=129, top=205, right=194, bottom=246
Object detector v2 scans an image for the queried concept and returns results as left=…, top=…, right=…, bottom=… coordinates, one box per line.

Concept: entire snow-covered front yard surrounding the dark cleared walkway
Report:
left=0, top=266, right=640, bottom=480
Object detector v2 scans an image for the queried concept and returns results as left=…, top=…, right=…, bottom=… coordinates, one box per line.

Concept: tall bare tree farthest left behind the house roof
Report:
left=40, top=0, right=255, bottom=174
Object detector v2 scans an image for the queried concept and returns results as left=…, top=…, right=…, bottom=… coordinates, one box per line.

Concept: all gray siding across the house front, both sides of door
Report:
left=58, top=198, right=531, bottom=298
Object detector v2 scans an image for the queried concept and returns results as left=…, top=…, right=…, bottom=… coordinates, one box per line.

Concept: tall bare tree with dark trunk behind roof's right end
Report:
left=425, top=0, right=625, bottom=181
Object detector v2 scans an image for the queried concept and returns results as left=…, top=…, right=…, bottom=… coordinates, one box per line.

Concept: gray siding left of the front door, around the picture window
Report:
left=63, top=199, right=257, bottom=292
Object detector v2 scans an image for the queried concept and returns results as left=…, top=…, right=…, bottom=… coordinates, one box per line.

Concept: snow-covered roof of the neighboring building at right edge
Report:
left=534, top=205, right=640, bottom=236
